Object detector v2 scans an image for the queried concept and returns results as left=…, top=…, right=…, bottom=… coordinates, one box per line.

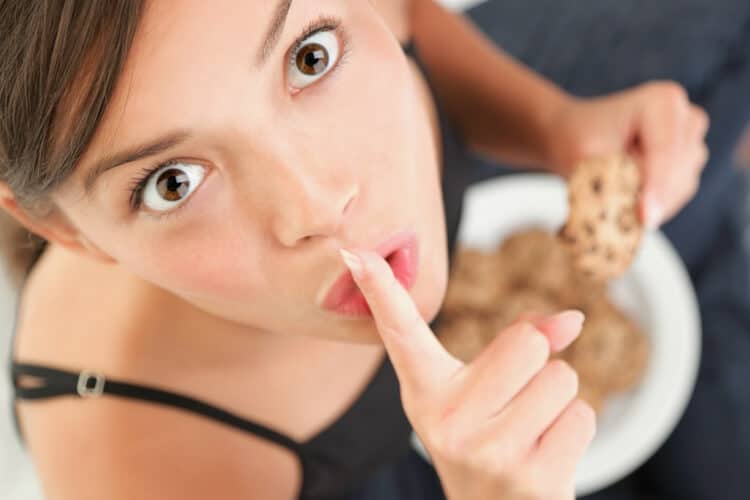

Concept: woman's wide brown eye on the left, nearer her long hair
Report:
left=142, top=163, right=205, bottom=212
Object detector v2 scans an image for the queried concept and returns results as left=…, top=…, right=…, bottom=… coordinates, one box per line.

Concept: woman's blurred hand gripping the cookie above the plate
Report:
left=546, top=82, right=709, bottom=228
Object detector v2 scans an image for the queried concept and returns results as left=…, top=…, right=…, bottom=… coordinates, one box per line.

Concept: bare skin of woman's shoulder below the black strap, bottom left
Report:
left=19, top=376, right=301, bottom=500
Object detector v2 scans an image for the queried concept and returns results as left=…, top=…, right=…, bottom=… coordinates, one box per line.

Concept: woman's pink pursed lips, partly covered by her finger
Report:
left=323, top=231, right=419, bottom=316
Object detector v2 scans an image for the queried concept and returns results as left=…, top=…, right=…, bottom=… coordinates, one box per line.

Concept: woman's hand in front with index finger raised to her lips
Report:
left=342, top=252, right=596, bottom=500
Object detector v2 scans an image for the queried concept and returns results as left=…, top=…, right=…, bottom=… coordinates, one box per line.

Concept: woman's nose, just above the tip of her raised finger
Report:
left=271, top=164, right=359, bottom=248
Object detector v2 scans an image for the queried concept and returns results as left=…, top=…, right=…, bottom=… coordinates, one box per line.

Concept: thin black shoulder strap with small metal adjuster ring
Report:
left=11, top=362, right=301, bottom=456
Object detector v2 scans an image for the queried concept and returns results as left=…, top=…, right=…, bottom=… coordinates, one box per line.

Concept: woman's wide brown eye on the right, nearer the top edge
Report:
left=288, top=30, right=341, bottom=89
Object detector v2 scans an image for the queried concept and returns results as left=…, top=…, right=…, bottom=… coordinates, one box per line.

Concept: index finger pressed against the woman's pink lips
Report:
left=341, top=250, right=462, bottom=394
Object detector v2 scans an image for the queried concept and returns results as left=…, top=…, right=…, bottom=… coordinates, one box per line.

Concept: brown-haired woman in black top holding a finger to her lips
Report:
left=0, top=0, right=707, bottom=500
